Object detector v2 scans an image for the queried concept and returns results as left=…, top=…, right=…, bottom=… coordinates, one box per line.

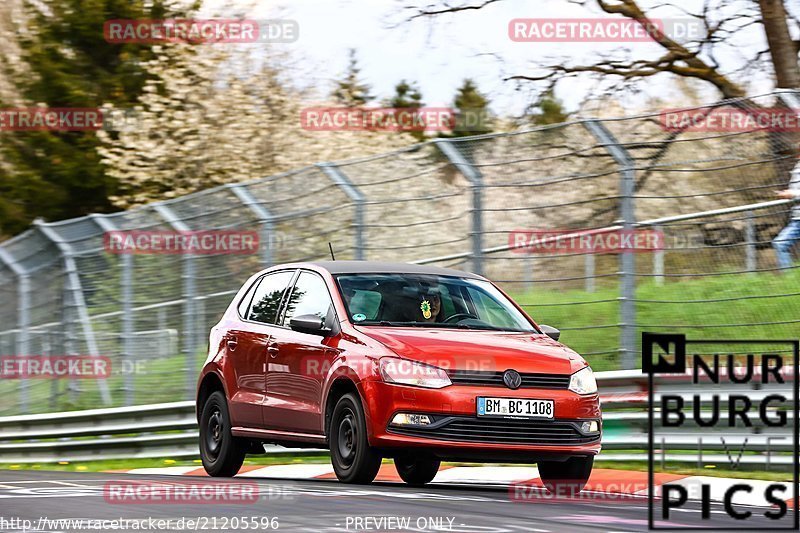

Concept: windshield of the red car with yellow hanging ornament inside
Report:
left=337, top=274, right=537, bottom=332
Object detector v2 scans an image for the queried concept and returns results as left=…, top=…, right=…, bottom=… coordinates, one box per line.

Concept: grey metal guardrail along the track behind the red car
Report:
left=0, top=370, right=793, bottom=465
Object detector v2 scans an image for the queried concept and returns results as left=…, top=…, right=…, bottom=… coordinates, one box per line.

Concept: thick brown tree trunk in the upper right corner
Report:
left=758, top=0, right=800, bottom=89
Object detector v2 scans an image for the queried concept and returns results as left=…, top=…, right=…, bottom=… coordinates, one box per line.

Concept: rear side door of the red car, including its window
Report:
left=224, top=270, right=294, bottom=428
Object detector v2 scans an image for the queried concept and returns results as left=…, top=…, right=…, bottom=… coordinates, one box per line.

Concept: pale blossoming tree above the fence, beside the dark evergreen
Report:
left=100, top=44, right=415, bottom=208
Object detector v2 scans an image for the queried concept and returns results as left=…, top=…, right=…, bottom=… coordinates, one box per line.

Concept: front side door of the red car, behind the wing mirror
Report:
left=264, top=270, right=337, bottom=434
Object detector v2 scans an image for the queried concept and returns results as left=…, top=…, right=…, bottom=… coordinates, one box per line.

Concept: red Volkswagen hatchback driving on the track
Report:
left=197, top=261, right=601, bottom=488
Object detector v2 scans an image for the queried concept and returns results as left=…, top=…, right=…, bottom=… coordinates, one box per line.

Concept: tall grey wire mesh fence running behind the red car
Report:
left=0, top=92, right=800, bottom=415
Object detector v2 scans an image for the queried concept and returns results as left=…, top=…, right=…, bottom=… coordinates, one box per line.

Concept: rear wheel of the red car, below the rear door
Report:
left=200, top=391, right=247, bottom=477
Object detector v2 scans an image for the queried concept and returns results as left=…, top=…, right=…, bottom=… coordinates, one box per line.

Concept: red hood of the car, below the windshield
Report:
left=358, top=326, right=586, bottom=374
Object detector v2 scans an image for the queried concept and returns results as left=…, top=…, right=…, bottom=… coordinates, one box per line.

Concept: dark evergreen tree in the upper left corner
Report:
left=0, top=0, right=197, bottom=233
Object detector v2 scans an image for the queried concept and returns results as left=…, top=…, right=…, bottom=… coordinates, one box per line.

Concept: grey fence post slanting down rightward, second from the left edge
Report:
left=33, top=218, right=111, bottom=405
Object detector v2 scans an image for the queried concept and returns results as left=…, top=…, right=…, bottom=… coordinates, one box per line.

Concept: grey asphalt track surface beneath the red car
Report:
left=0, top=471, right=794, bottom=533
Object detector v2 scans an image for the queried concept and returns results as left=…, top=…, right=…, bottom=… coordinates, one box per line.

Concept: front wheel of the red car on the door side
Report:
left=328, top=393, right=382, bottom=484
